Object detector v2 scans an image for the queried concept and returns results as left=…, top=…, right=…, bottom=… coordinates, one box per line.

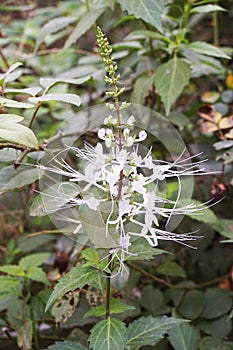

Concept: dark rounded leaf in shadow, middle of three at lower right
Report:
left=179, top=290, right=205, bottom=320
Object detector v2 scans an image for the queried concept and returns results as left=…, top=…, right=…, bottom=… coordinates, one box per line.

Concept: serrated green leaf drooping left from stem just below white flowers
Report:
left=46, top=266, right=98, bottom=311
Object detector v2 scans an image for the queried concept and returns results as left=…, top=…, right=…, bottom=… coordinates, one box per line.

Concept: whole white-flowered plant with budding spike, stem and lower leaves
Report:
left=31, top=28, right=218, bottom=349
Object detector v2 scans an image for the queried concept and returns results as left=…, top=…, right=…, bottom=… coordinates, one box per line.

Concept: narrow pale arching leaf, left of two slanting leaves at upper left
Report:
left=35, top=17, right=77, bottom=51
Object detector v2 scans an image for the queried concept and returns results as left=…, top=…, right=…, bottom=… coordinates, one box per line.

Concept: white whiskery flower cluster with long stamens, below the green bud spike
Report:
left=37, top=115, right=212, bottom=253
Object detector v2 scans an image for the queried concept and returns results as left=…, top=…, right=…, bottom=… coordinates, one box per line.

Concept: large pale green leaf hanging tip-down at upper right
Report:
left=154, top=56, right=191, bottom=115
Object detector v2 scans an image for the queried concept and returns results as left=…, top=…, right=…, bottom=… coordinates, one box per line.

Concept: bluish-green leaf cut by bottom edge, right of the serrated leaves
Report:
left=169, top=324, right=200, bottom=350
